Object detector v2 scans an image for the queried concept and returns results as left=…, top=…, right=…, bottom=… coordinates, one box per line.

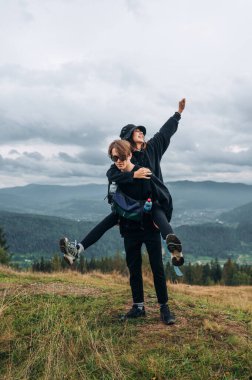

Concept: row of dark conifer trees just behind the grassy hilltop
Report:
left=32, top=252, right=252, bottom=286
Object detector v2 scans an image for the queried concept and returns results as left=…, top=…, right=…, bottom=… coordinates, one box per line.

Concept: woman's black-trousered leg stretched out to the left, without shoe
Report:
left=81, top=212, right=118, bottom=250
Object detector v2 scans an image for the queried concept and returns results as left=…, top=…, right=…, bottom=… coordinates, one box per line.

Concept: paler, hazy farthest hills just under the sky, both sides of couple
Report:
left=0, top=181, right=252, bottom=225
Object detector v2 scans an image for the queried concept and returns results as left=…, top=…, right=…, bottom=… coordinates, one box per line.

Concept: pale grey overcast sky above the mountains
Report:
left=0, top=0, right=252, bottom=187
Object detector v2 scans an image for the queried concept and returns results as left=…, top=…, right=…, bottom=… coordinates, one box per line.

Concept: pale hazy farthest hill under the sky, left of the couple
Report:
left=0, top=184, right=110, bottom=220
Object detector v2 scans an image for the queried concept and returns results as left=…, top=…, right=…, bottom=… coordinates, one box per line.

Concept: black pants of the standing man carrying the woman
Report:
left=124, top=230, right=168, bottom=304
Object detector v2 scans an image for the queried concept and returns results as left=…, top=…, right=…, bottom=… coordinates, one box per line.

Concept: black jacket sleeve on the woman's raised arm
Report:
left=147, top=112, right=181, bottom=159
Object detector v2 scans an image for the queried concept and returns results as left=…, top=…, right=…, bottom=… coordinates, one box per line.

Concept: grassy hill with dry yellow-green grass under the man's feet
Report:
left=0, top=267, right=252, bottom=380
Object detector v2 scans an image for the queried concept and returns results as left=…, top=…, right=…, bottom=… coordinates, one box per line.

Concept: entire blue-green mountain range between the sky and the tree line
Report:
left=0, top=181, right=252, bottom=265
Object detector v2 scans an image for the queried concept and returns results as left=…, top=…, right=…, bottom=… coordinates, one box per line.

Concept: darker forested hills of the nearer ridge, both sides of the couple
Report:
left=0, top=211, right=252, bottom=263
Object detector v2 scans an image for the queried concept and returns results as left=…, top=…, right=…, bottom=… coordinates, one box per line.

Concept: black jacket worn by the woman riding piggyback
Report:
left=107, top=112, right=181, bottom=222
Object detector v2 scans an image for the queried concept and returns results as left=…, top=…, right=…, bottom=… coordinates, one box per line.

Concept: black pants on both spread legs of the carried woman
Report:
left=81, top=203, right=173, bottom=250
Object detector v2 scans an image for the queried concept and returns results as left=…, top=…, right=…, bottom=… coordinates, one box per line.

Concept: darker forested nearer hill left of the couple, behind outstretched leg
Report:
left=0, top=211, right=123, bottom=261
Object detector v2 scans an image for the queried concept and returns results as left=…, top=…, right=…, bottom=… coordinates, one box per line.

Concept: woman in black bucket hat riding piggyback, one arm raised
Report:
left=60, top=99, right=185, bottom=266
